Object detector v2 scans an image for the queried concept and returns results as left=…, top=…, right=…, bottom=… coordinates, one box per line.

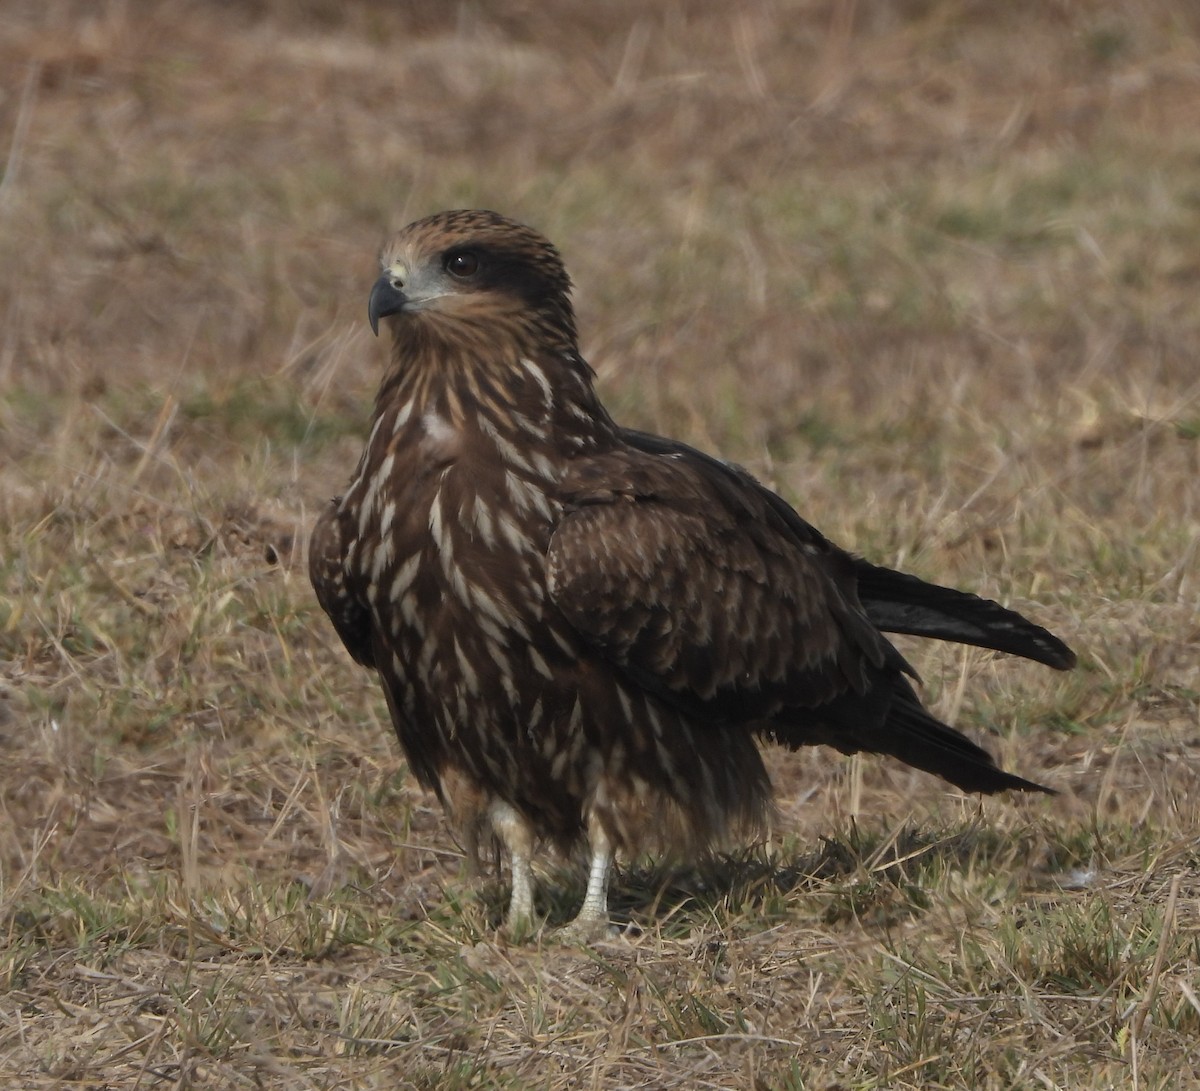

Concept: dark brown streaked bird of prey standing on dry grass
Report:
left=310, top=211, right=1074, bottom=935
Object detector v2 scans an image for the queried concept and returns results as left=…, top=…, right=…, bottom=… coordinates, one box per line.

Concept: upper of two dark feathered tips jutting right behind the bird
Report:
left=854, top=557, right=1075, bottom=671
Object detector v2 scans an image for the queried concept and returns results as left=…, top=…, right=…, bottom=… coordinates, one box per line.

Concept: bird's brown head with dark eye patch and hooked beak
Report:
left=367, top=210, right=575, bottom=350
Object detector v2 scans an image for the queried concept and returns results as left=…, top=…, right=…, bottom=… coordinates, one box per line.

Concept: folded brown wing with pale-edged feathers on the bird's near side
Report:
left=547, top=449, right=907, bottom=721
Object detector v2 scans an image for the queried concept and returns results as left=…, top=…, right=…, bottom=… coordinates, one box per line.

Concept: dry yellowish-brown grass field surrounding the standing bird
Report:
left=0, top=0, right=1200, bottom=1091
